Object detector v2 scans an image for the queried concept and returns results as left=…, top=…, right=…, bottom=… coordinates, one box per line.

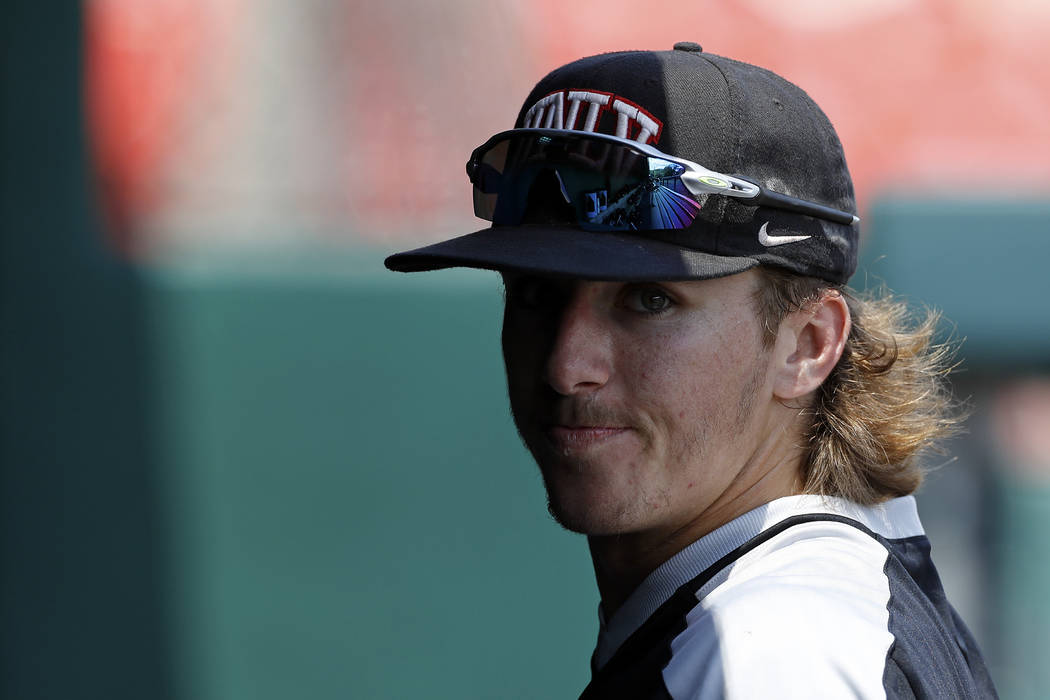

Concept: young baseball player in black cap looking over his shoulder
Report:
left=386, top=43, right=995, bottom=698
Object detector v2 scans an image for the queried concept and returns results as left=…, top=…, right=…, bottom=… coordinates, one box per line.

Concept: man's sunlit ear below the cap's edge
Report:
left=773, top=290, right=851, bottom=400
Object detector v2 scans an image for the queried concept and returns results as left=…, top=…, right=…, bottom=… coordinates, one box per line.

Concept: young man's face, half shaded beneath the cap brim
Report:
left=503, top=271, right=772, bottom=535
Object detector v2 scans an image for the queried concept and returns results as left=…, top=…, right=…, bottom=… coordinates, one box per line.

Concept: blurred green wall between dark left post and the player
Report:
left=147, top=256, right=597, bottom=699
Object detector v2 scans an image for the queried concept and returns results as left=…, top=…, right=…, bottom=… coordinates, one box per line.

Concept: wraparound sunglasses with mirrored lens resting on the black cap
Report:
left=466, top=129, right=860, bottom=231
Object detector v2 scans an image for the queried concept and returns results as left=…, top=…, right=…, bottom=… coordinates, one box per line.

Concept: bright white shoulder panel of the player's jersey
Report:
left=665, top=521, right=894, bottom=697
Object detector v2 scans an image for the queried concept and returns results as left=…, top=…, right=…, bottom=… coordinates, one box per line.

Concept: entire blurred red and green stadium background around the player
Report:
left=6, top=0, right=1050, bottom=700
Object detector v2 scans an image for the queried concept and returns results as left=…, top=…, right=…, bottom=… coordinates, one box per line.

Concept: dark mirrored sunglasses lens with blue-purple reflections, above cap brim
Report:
left=471, top=132, right=700, bottom=231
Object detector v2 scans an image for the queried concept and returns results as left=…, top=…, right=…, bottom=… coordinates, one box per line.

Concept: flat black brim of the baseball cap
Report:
left=386, top=226, right=759, bottom=281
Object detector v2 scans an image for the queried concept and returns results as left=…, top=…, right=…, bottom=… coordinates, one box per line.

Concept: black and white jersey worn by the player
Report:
left=582, top=495, right=995, bottom=700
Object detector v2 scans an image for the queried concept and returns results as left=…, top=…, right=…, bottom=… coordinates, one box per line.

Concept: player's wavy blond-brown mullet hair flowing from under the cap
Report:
left=756, top=268, right=963, bottom=504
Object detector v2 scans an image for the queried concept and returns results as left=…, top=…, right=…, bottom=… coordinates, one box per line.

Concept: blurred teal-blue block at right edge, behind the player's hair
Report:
left=852, top=192, right=1050, bottom=372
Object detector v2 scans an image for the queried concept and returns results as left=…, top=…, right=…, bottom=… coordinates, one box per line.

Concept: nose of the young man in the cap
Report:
left=544, top=284, right=612, bottom=396
